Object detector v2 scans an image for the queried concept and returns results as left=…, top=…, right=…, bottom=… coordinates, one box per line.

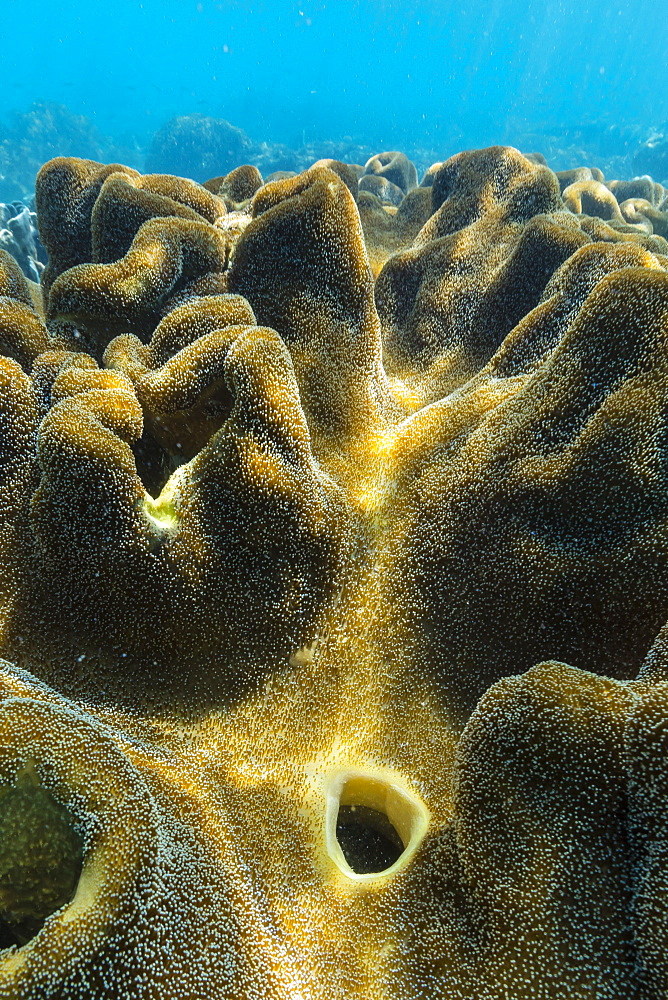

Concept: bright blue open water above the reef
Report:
left=0, top=0, right=668, bottom=170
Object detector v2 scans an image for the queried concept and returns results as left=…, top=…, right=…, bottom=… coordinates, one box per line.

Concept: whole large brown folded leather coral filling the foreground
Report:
left=0, top=147, right=668, bottom=1000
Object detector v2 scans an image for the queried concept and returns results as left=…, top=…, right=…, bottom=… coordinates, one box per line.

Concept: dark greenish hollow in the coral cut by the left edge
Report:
left=0, top=766, right=83, bottom=948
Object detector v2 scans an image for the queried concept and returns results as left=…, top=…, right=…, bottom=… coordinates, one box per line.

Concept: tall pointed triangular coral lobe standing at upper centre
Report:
left=228, top=167, right=387, bottom=440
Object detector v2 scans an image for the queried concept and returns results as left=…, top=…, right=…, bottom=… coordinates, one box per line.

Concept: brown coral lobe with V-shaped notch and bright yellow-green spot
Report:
left=14, top=320, right=339, bottom=697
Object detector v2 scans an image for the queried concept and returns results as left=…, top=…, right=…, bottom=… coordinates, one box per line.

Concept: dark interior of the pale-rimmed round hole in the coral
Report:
left=336, top=805, right=404, bottom=875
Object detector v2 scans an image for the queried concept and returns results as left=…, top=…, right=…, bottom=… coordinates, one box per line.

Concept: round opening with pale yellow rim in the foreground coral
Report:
left=327, top=771, right=429, bottom=882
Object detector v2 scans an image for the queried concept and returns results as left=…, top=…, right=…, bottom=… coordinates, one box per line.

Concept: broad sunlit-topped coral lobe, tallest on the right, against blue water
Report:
left=376, top=148, right=588, bottom=394
